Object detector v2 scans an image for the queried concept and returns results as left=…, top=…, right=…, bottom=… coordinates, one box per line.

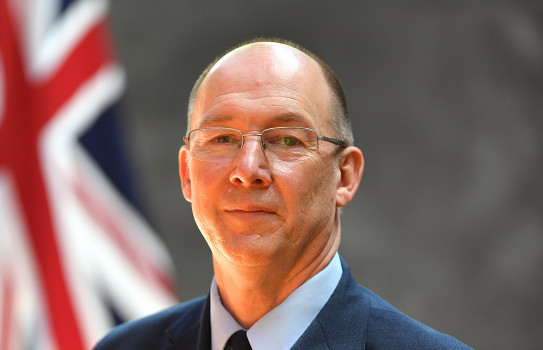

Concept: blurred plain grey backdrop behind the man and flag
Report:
left=111, top=0, right=543, bottom=349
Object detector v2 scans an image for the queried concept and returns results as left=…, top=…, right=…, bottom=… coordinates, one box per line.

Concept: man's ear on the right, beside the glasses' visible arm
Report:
left=336, top=146, right=364, bottom=207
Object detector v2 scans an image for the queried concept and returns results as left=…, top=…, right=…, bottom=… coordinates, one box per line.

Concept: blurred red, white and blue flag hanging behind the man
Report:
left=0, top=0, right=180, bottom=350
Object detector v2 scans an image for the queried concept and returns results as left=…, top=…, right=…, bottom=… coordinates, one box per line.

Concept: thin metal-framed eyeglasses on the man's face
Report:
left=183, top=127, right=347, bottom=162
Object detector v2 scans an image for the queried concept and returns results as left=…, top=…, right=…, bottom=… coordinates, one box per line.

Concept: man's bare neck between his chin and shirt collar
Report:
left=213, top=227, right=340, bottom=329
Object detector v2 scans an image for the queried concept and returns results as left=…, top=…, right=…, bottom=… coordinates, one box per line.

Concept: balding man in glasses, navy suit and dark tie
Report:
left=96, top=40, right=468, bottom=350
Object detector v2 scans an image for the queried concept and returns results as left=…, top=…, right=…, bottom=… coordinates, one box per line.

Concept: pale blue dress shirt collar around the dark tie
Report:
left=210, top=253, right=343, bottom=350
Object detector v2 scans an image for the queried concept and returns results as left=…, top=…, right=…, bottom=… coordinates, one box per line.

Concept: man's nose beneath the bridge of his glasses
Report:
left=230, top=135, right=272, bottom=187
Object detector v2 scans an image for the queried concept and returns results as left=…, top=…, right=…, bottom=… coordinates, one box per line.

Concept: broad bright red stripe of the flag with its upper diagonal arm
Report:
left=0, top=0, right=116, bottom=350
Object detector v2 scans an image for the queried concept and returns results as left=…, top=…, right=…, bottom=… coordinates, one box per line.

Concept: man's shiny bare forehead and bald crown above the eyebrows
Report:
left=192, top=43, right=331, bottom=128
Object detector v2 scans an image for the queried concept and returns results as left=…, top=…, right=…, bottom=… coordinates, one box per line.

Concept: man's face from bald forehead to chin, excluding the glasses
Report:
left=180, top=44, right=340, bottom=268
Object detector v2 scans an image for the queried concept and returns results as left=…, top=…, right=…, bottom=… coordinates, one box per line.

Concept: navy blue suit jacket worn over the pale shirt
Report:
left=95, top=259, right=470, bottom=350
